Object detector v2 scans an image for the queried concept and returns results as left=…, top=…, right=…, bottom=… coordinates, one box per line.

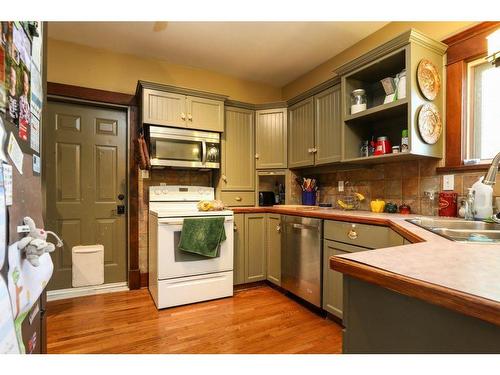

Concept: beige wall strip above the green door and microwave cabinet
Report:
left=47, top=39, right=281, bottom=103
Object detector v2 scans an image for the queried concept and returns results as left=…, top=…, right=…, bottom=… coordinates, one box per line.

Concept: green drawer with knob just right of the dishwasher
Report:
left=324, top=220, right=403, bottom=249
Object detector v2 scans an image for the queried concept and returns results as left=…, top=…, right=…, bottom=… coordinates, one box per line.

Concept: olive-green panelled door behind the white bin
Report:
left=43, top=102, right=127, bottom=289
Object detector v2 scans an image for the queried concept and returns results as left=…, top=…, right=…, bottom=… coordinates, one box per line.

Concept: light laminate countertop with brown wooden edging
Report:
left=232, top=206, right=500, bottom=325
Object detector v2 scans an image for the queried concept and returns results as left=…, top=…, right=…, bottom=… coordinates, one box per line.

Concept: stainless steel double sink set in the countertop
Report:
left=406, top=217, right=500, bottom=244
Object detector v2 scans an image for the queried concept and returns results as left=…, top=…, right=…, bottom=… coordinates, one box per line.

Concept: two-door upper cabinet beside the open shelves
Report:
left=288, top=85, right=342, bottom=168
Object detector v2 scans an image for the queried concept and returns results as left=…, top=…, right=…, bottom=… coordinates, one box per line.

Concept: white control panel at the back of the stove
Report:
left=149, top=185, right=215, bottom=202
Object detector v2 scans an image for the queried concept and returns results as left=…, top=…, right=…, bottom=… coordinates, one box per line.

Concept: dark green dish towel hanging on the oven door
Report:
left=179, top=217, right=226, bottom=258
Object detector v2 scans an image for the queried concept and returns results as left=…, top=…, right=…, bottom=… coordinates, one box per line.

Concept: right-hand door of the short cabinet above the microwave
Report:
left=186, top=96, right=224, bottom=132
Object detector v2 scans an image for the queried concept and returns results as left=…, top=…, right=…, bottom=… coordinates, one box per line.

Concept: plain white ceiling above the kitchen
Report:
left=49, top=22, right=387, bottom=87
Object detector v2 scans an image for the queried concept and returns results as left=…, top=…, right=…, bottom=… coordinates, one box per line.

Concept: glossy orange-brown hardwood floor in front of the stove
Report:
left=47, top=286, right=342, bottom=353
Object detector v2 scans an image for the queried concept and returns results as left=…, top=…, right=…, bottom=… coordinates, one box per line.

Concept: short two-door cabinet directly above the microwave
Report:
left=142, top=88, right=224, bottom=132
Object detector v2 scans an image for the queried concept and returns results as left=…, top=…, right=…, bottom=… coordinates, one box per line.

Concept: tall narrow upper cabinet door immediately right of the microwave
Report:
left=220, top=107, right=255, bottom=191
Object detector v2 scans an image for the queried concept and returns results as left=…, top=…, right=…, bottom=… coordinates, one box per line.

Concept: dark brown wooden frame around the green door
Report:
left=47, top=82, right=141, bottom=289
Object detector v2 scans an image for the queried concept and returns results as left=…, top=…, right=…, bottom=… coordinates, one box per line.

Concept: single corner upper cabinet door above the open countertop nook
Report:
left=255, top=108, right=287, bottom=169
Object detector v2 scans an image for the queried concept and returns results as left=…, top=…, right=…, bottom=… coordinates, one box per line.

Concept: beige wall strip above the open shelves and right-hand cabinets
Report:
left=282, top=22, right=476, bottom=100
